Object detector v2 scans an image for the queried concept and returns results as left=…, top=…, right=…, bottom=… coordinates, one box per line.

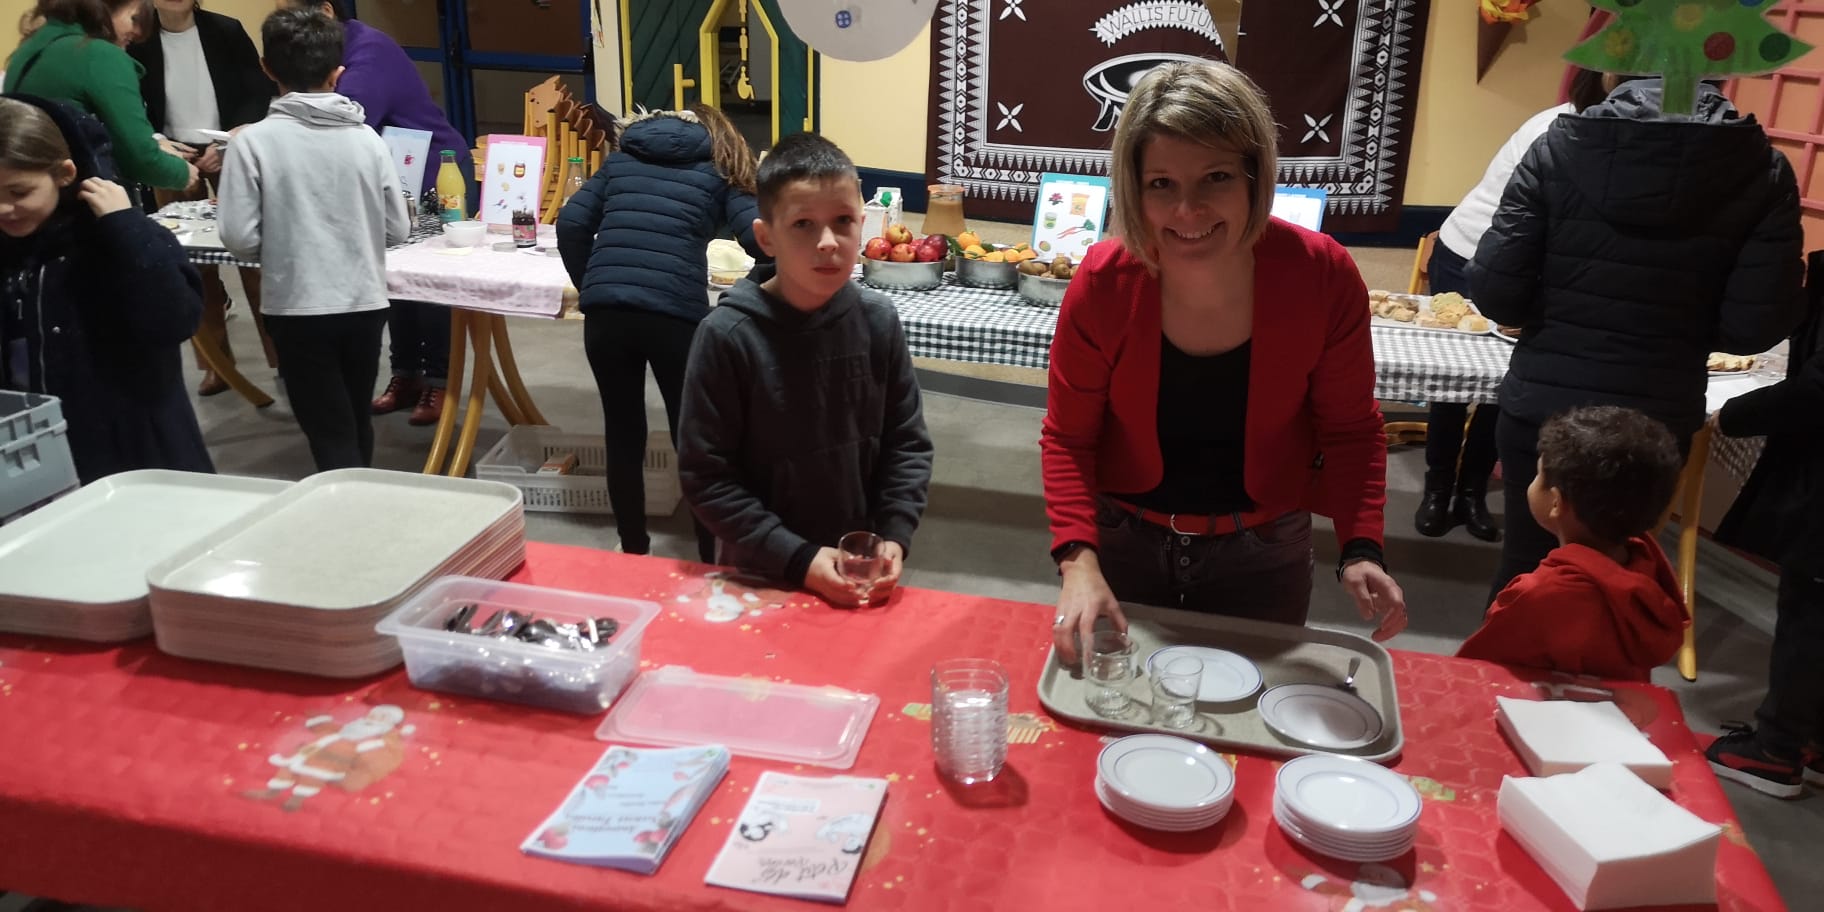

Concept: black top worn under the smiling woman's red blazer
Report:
left=1114, top=336, right=1253, bottom=516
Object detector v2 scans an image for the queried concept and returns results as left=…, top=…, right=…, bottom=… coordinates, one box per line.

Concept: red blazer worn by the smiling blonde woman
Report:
left=1040, top=219, right=1386, bottom=549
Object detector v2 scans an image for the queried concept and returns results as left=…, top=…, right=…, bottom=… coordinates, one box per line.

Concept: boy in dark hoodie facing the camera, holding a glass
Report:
left=679, top=133, right=932, bottom=606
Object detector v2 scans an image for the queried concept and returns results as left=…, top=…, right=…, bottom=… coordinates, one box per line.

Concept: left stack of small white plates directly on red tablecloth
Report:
left=1096, top=735, right=1235, bottom=834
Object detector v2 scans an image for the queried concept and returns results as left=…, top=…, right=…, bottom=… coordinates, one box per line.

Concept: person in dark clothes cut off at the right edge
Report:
left=1705, top=271, right=1824, bottom=797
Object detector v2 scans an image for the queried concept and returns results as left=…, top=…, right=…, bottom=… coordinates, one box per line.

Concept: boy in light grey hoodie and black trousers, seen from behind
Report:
left=217, top=9, right=412, bottom=471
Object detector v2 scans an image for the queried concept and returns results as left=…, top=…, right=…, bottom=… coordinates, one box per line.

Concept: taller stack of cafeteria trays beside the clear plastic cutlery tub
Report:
left=148, top=469, right=525, bottom=677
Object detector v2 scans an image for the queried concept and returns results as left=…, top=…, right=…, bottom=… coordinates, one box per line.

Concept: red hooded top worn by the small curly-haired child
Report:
left=1457, top=536, right=1691, bottom=680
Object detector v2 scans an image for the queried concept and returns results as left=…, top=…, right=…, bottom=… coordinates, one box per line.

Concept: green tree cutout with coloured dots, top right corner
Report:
left=1565, top=0, right=1811, bottom=113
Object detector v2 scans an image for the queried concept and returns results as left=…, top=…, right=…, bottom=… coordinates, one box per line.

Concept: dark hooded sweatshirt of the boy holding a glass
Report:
left=677, top=279, right=932, bottom=586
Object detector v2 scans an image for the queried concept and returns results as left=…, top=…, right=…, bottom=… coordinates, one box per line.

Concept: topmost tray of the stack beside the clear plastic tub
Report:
left=148, top=469, right=522, bottom=611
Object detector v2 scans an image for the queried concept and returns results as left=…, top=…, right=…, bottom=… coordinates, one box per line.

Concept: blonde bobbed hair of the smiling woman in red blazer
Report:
left=1109, top=60, right=1279, bottom=268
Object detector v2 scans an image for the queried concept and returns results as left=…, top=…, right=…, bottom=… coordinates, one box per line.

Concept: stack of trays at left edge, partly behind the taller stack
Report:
left=0, top=469, right=292, bottom=642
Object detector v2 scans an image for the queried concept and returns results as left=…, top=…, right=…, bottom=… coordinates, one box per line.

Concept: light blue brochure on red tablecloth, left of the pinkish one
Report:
left=520, top=744, right=728, bottom=874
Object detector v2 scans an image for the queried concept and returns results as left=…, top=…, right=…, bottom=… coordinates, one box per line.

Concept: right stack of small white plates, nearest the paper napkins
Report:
left=1273, top=753, right=1423, bottom=861
